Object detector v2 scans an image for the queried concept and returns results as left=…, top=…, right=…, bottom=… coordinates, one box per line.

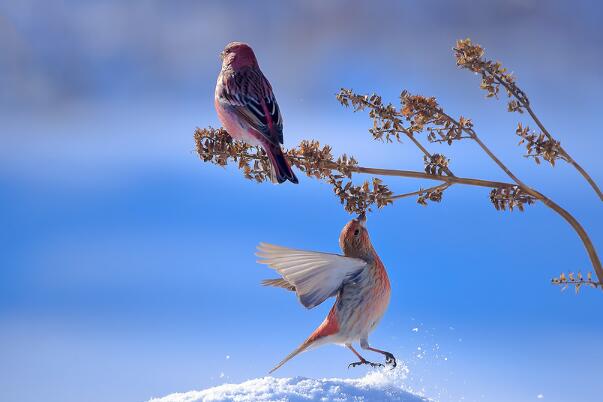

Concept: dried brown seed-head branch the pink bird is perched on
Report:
left=195, top=128, right=603, bottom=283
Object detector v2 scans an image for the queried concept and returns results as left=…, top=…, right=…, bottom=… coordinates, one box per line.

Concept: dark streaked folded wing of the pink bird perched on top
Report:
left=217, top=68, right=283, bottom=144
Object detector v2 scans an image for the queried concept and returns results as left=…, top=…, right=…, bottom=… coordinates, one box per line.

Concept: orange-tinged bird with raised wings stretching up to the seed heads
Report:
left=256, top=214, right=396, bottom=373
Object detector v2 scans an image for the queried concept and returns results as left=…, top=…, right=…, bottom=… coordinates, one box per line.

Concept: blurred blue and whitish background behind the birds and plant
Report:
left=0, top=0, right=603, bottom=401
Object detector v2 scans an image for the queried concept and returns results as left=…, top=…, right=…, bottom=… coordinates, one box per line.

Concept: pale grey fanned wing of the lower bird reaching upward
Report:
left=256, top=243, right=367, bottom=308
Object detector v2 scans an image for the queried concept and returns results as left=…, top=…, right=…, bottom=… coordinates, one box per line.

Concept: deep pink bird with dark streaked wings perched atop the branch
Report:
left=214, top=42, right=297, bottom=183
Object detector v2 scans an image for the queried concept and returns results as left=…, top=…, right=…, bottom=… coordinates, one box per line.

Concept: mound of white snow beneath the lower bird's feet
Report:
left=149, top=367, right=429, bottom=402
